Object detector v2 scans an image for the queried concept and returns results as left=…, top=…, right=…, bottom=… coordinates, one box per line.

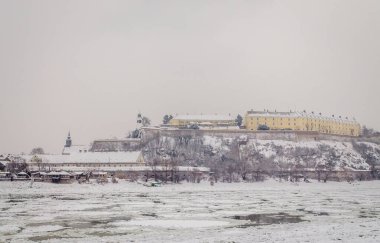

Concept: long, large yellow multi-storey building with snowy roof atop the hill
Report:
left=244, top=110, right=361, bottom=136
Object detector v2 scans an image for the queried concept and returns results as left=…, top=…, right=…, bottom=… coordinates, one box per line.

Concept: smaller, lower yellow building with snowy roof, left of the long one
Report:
left=169, top=115, right=236, bottom=127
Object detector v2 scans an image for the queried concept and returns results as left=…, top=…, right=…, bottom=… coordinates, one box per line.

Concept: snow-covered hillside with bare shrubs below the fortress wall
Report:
left=143, top=135, right=380, bottom=173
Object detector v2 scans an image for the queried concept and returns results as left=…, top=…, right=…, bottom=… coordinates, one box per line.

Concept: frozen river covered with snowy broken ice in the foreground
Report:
left=0, top=181, right=380, bottom=242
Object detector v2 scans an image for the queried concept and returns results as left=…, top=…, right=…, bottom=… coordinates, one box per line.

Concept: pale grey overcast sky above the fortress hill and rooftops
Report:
left=0, top=0, right=380, bottom=153
